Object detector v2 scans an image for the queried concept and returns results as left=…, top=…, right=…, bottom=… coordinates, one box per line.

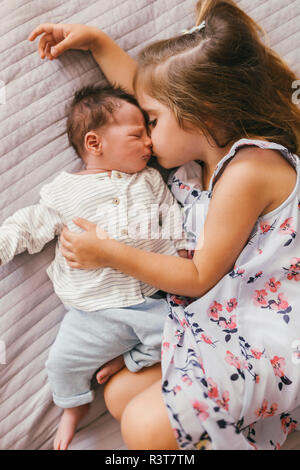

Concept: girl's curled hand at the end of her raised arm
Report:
left=28, top=23, right=100, bottom=60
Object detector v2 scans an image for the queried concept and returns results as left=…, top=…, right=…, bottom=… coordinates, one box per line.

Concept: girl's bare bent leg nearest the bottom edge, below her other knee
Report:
left=121, top=380, right=178, bottom=450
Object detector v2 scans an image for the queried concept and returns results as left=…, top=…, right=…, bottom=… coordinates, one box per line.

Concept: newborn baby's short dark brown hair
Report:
left=67, top=85, right=147, bottom=158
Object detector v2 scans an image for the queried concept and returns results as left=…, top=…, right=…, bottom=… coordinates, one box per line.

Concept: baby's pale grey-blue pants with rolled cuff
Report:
left=46, top=297, right=169, bottom=408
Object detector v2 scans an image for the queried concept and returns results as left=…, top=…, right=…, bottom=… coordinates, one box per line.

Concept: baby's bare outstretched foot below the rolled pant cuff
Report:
left=53, top=403, right=89, bottom=450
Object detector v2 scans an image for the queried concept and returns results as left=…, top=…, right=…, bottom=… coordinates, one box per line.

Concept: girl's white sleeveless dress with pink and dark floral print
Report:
left=162, top=139, right=300, bottom=450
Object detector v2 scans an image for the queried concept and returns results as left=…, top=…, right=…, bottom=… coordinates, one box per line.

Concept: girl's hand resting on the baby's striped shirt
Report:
left=60, top=218, right=110, bottom=269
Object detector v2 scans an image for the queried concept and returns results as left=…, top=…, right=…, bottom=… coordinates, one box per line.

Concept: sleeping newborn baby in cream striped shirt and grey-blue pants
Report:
left=0, top=86, right=186, bottom=450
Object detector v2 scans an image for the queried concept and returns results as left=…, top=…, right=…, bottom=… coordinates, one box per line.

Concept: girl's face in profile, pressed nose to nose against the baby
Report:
left=139, top=94, right=206, bottom=168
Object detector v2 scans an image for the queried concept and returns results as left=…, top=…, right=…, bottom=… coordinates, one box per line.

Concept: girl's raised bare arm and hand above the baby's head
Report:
left=28, top=23, right=137, bottom=93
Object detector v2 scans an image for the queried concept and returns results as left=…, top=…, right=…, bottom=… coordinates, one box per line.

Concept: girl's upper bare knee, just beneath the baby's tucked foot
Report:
left=104, top=364, right=161, bottom=421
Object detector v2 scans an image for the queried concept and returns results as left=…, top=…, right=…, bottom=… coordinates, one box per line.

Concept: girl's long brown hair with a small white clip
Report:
left=134, top=0, right=300, bottom=153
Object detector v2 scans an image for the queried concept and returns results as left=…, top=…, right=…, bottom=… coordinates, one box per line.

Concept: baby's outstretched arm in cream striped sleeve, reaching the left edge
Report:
left=0, top=187, right=63, bottom=265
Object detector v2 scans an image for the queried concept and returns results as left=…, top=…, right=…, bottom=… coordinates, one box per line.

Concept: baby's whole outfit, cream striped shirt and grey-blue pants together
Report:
left=0, top=167, right=186, bottom=408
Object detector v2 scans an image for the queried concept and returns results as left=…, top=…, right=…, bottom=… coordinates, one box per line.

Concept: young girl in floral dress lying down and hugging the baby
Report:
left=30, top=0, right=300, bottom=449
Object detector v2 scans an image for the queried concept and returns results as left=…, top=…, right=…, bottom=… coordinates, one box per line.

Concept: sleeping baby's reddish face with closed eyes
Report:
left=99, top=101, right=152, bottom=173
